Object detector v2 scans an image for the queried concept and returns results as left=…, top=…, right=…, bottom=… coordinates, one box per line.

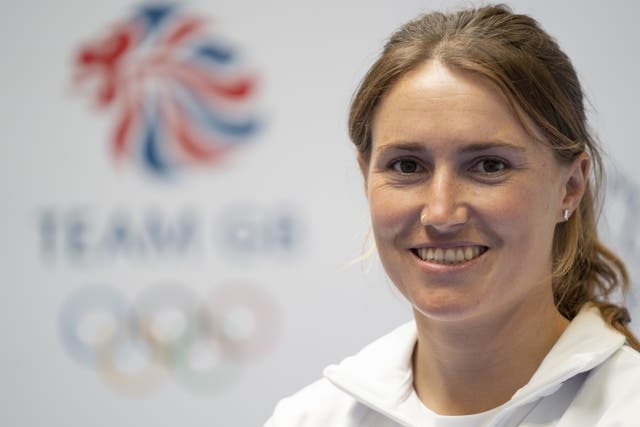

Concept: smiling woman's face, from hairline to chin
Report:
left=361, top=61, right=588, bottom=320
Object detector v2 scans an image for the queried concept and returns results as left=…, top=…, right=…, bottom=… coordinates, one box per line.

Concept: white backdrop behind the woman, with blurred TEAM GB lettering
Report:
left=0, top=0, right=640, bottom=427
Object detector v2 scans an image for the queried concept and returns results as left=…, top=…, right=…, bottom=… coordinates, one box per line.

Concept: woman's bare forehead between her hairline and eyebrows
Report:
left=372, top=61, right=542, bottom=151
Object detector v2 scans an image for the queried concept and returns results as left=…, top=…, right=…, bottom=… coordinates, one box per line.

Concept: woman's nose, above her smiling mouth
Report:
left=420, top=168, right=469, bottom=233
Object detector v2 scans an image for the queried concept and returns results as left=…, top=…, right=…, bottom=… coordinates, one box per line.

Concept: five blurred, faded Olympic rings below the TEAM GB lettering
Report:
left=58, top=284, right=280, bottom=394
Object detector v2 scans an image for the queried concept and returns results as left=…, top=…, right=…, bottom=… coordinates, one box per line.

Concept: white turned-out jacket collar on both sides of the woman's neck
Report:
left=324, top=304, right=625, bottom=423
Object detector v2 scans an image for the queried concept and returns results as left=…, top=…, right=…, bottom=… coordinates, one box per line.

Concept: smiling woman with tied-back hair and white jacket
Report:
left=267, top=6, right=640, bottom=426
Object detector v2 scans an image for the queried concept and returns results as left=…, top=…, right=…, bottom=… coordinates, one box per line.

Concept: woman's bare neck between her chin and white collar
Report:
left=413, top=301, right=568, bottom=415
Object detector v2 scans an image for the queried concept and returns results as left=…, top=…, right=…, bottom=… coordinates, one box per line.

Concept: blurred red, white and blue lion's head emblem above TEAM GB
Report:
left=75, top=5, right=260, bottom=175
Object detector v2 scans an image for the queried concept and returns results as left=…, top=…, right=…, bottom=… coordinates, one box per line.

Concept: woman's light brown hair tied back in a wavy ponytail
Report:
left=349, top=5, right=640, bottom=350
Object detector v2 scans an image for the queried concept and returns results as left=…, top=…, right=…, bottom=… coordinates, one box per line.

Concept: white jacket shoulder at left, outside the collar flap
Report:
left=265, top=378, right=366, bottom=427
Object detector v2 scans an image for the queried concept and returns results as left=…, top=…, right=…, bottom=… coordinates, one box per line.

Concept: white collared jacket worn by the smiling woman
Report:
left=265, top=307, right=640, bottom=427
